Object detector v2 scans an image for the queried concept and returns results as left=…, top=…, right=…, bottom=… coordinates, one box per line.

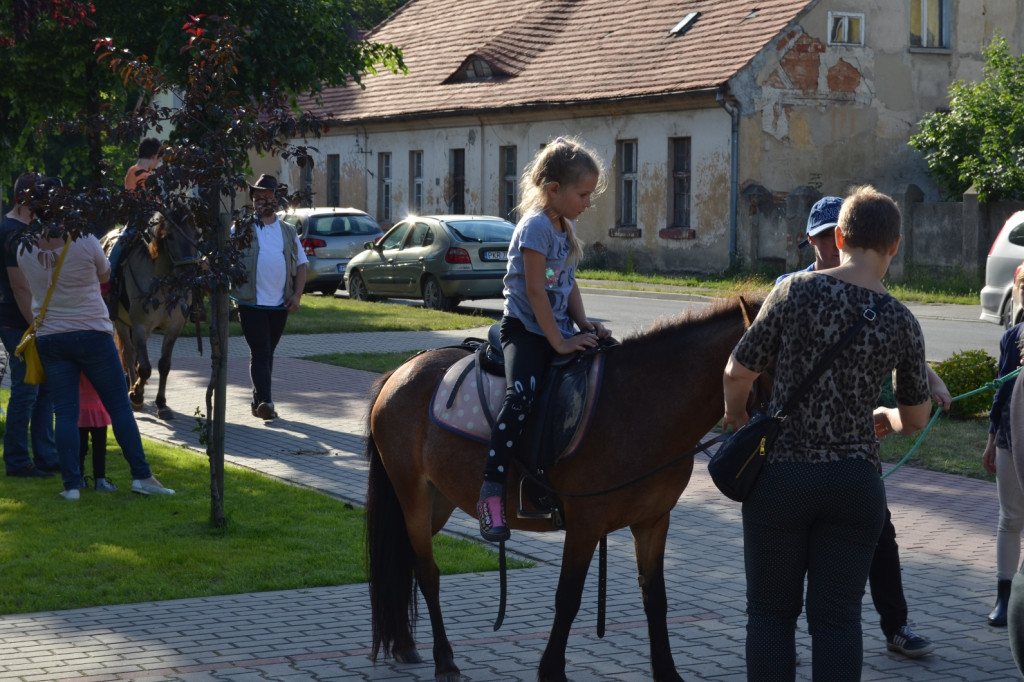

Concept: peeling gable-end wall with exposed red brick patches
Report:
left=729, top=0, right=1024, bottom=267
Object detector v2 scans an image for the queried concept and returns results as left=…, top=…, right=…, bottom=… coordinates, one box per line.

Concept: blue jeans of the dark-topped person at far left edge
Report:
left=0, top=327, right=57, bottom=473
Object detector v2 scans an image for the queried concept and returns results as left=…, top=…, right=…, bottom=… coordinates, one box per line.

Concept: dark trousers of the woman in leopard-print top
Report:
left=743, top=460, right=886, bottom=682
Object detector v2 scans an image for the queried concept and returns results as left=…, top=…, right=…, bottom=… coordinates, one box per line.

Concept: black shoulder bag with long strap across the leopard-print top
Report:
left=708, top=296, right=892, bottom=502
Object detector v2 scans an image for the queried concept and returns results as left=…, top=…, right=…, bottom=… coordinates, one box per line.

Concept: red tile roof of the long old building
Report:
left=311, top=0, right=813, bottom=121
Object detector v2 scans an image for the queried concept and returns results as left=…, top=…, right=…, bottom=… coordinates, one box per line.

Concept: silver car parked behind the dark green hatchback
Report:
left=278, top=207, right=384, bottom=296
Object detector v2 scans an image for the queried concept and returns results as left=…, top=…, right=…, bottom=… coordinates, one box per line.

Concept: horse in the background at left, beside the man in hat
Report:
left=102, top=213, right=197, bottom=419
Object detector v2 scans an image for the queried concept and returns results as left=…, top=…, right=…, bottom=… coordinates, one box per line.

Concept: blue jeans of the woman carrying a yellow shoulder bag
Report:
left=36, top=330, right=153, bottom=489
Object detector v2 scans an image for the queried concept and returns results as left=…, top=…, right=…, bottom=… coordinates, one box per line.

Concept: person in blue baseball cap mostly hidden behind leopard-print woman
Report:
left=775, top=192, right=952, bottom=658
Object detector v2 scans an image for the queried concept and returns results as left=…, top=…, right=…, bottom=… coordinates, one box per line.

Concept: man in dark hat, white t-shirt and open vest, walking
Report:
left=231, top=173, right=308, bottom=420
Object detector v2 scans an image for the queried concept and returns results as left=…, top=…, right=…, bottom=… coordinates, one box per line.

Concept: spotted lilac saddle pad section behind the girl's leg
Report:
left=430, top=353, right=505, bottom=443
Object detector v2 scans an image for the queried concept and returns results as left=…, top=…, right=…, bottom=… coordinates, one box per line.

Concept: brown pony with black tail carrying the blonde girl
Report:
left=367, top=298, right=760, bottom=682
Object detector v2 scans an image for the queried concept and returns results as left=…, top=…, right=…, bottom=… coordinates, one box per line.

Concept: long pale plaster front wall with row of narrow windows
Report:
left=296, top=105, right=730, bottom=271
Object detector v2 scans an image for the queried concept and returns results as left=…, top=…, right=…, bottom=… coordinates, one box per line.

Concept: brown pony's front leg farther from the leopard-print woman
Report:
left=537, top=530, right=599, bottom=682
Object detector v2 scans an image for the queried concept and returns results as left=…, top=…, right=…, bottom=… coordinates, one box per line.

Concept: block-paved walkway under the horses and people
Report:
left=0, top=330, right=1021, bottom=682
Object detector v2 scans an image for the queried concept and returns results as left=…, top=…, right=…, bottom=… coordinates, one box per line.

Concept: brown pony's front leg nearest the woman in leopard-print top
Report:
left=630, top=513, right=683, bottom=682
